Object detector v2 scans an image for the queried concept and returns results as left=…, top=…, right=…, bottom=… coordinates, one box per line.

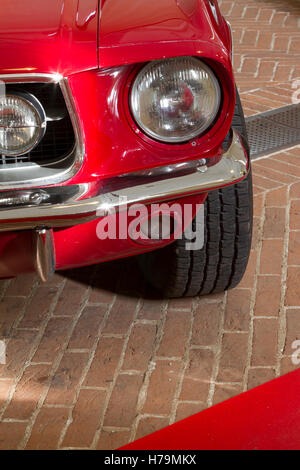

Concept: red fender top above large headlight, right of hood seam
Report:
left=99, top=0, right=231, bottom=67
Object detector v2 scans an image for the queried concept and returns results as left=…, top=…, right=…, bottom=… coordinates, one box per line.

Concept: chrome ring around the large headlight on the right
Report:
left=129, top=56, right=222, bottom=144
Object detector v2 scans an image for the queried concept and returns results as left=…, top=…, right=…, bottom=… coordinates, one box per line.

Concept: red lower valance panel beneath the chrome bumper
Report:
left=0, top=193, right=206, bottom=278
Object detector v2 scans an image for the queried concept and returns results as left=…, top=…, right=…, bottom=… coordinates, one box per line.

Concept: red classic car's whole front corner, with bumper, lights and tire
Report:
left=0, top=0, right=252, bottom=297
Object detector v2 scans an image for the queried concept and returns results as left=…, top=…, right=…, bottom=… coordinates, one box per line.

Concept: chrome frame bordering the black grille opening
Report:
left=0, top=73, right=85, bottom=190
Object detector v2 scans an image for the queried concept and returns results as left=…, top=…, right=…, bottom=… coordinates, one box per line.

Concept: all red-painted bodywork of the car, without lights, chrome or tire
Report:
left=0, top=0, right=239, bottom=277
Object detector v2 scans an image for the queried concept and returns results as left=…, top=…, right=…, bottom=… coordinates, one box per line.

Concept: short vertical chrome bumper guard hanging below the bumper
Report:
left=34, top=229, right=56, bottom=282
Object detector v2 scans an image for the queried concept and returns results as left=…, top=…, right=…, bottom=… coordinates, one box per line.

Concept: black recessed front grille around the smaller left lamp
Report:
left=0, top=83, right=75, bottom=169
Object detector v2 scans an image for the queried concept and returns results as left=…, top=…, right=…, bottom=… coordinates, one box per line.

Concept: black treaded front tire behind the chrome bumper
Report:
left=138, top=88, right=253, bottom=298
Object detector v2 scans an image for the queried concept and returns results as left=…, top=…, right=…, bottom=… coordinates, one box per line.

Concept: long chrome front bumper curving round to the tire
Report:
left=0, top=131, right=249, bottom=232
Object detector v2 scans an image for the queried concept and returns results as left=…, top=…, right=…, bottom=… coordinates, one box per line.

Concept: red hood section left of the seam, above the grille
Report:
left=0, top=0, right=98, bottom=75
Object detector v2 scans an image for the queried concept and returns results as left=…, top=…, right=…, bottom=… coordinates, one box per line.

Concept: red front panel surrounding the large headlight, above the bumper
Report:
left=65, top=66, right=234, bottom=184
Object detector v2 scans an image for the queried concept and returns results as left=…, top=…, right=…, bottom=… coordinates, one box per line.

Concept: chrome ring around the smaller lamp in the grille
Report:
left=0, top=91, right=47, bottom=157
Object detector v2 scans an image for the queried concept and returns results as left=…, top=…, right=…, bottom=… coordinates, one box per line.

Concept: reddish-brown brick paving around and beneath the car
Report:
left=0, top=0, right=300, bottom=449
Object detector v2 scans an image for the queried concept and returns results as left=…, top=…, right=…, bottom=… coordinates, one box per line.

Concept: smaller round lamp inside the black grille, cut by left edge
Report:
left=0, top=92, right=46, bottom=156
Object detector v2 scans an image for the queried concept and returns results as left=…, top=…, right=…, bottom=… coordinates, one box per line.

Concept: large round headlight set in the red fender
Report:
left=130, top=57, right=221, bottom=143
